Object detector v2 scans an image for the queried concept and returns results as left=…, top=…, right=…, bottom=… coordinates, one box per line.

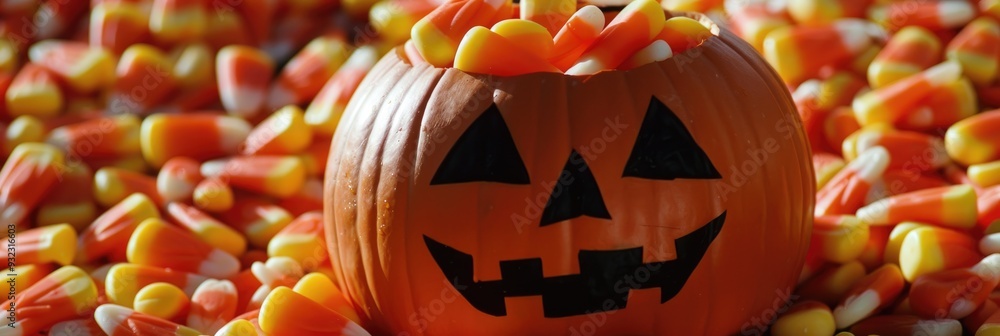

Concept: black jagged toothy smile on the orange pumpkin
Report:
left=424, top=212, right=726, bottom=317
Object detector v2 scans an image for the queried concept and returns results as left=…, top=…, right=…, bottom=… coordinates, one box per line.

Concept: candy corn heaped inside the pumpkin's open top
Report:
left=403, top=0, right=718, bottom=76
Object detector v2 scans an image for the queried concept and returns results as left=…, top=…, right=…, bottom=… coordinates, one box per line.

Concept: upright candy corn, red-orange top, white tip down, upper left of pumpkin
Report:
left=215, top=46, right=274, bottom=118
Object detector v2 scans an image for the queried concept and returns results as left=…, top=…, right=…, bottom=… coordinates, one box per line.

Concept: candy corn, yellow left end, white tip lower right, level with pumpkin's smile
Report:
left=127, top=218, right=239, bottom=278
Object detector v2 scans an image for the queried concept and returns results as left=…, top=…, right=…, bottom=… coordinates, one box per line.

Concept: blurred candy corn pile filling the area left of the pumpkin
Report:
left=0, top=0, right=450, bottom=336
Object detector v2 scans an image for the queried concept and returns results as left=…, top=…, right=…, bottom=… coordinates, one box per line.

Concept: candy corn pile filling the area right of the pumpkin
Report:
left=708, top=0, right=1000, bottom=335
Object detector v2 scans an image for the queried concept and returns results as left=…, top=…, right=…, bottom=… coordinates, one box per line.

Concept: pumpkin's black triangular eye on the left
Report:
left=431, top=104, right=530, bottom=185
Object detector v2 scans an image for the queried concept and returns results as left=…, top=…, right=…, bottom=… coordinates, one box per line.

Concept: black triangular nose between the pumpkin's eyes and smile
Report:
left=541, top=150, right=611, bottom=226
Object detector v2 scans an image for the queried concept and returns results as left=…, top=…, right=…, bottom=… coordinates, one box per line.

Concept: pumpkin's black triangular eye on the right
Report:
left=622, top=97, right=722, bottom=180
